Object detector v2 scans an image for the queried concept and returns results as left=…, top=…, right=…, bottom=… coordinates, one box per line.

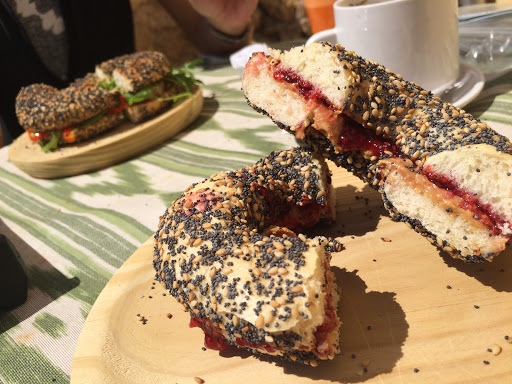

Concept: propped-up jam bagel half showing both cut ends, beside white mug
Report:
left=242, top=43, right=512, bottom=262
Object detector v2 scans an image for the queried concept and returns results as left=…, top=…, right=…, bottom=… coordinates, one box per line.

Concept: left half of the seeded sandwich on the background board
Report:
left=15, top=74, right=124, bottom=152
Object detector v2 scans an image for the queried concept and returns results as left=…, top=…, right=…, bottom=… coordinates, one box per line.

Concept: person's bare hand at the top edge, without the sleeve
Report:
left=188, top=0, right=258, bottom=36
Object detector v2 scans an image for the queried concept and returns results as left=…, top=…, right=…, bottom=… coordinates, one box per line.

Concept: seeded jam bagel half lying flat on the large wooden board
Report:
left=153, top=148, right=340, bottom=366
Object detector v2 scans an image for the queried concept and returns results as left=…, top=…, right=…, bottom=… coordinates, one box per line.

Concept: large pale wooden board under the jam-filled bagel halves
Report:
left=71, top=167, right=512, bottom=384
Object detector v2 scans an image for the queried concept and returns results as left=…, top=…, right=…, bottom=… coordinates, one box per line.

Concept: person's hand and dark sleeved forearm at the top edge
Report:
left=159, top=0, right=258, bottom=54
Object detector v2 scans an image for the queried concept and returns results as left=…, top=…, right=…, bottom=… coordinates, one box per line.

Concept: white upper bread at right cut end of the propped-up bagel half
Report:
left=425, top=144, right=512, bottom=235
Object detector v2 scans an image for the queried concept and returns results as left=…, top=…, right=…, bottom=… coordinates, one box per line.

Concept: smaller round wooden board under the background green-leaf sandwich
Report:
left=8, top=86, right=203, bottom=179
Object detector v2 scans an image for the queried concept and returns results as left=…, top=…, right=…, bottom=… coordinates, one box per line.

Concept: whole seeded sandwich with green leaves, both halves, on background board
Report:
left=15, top=51, right=200, bottom=152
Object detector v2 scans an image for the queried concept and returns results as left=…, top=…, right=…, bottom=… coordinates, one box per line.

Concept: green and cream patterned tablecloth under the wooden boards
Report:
left=0, top=60, right=512, bottom=384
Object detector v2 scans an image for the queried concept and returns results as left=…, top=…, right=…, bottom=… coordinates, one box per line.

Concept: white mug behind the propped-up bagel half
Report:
left=306, top=0, right=459, bottom=93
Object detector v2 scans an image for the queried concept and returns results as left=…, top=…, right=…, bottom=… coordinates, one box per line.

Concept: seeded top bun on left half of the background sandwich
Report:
left=15, top=74, right=121, bottom=132
